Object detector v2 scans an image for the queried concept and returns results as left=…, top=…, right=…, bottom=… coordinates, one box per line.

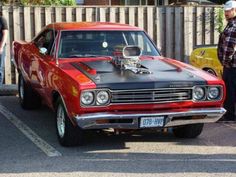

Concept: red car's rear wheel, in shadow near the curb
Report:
left=18, top=74, right=41, bottom=109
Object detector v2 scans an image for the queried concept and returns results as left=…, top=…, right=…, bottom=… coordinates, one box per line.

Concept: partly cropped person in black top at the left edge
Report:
left=0, top=16, right=8, bottom=85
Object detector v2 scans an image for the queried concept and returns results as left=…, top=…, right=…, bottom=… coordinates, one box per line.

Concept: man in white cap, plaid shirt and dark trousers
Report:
left=217, top=0, right=236, bottom=121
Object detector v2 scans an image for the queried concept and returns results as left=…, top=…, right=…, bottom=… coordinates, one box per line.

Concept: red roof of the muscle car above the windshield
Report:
left=46, top=22, right=142, bottom=31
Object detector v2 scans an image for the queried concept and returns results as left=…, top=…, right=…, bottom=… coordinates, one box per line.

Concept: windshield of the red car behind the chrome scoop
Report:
left=58, top=31, right=159, bottom=58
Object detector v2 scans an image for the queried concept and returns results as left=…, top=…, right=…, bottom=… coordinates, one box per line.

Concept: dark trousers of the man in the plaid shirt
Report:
left=223, top=67, right=236, bottom=120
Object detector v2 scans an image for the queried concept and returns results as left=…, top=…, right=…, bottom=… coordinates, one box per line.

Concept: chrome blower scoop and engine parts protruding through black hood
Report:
left=112, top=46, right=152, bottom=74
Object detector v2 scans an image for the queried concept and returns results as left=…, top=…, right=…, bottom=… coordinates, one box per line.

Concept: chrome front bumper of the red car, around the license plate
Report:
left=75, top=108, right=226, bottom=129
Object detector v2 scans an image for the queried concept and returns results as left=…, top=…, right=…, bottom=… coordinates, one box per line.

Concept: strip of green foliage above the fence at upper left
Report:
left=20, top=0, right=76, bottom=6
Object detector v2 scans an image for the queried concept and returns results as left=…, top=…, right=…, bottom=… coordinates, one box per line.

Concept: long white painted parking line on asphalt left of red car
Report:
left=0, top=104, right=61, bottom=157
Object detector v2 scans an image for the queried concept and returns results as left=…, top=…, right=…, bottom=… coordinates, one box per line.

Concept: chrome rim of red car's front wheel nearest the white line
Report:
left=57, top=104, right=65, bottom=138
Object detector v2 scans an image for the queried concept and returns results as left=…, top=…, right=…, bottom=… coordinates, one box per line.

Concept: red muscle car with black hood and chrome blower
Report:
left=13, top=22, right=225, bottom=146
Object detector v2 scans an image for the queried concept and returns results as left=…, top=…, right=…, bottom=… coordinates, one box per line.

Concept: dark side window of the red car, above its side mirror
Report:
left=34, top=30, right=56, bottom=54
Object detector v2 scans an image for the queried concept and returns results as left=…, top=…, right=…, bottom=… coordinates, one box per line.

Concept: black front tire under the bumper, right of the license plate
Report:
left=173, top=124, right=204, bottom=138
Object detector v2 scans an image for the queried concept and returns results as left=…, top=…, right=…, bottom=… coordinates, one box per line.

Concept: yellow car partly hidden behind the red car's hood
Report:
left=189, top=45, right=223, bottom=78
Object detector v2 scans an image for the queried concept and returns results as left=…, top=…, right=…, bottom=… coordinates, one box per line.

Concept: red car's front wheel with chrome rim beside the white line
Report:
left=55, top=98, right=83, bottom=146
